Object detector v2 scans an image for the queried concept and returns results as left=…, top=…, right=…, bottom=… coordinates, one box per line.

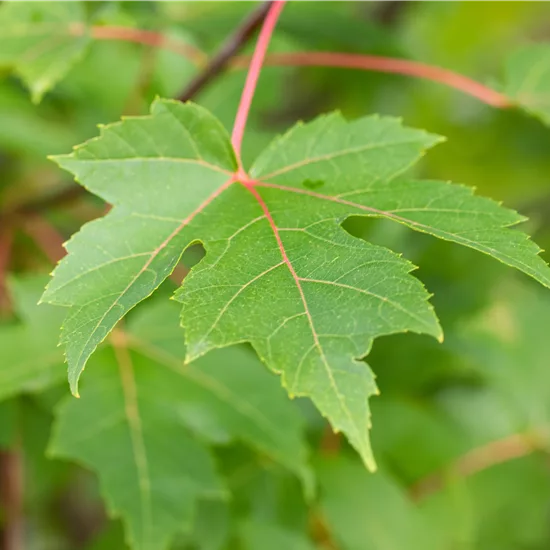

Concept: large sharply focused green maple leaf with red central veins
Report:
left=44, top=101, right=550, bottom=468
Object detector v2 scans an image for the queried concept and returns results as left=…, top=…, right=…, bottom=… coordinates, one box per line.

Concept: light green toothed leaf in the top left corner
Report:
left=0, top=0, right=90, bottom=102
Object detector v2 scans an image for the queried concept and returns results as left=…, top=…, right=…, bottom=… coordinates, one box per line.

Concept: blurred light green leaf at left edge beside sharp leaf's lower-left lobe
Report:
left=0, top=276, right=65, bottom=399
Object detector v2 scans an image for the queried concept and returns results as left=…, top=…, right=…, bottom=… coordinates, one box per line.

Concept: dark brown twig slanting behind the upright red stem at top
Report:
left=179, top=0, right=277, bottom=101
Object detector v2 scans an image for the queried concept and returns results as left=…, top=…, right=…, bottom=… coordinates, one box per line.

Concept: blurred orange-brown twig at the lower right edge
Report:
left=409, top=430, right=546, bottom=500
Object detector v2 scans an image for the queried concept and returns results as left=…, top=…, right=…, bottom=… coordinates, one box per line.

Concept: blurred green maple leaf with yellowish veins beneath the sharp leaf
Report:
left=50, top=302, right=311, bottom=550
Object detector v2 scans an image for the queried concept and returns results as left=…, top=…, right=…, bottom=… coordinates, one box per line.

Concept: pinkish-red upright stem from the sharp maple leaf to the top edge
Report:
left=231, top=0, right=286, bottom=170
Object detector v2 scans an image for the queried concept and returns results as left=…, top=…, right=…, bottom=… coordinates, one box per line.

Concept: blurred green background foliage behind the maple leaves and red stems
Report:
left=0, top=0, right=550, bottom=550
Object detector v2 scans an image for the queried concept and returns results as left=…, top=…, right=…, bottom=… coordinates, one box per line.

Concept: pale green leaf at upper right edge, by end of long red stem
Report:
left=505, top=44, right=550, bottom=125
